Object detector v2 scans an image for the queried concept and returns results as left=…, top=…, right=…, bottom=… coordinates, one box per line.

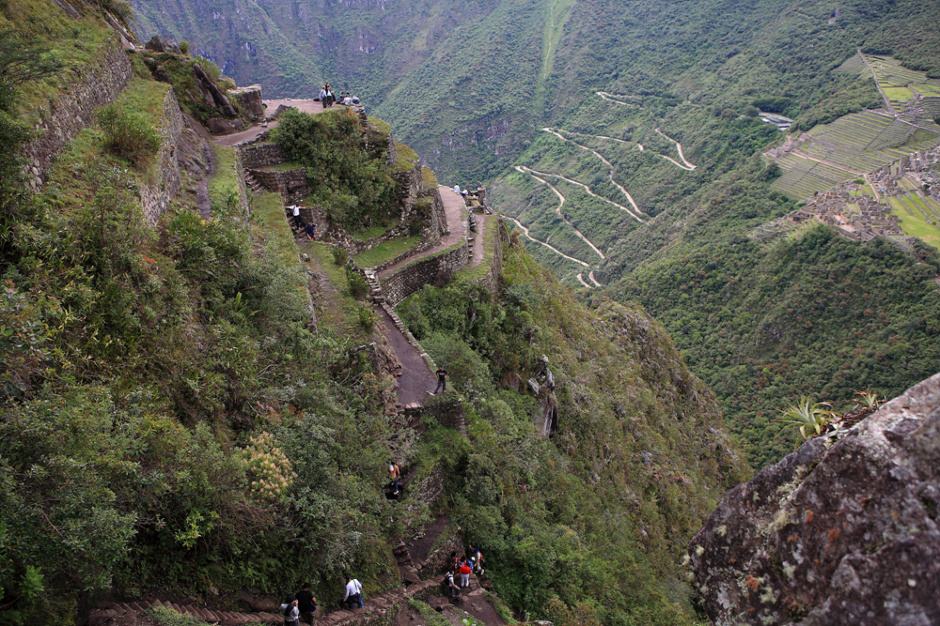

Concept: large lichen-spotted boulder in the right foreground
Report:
left=689, top=374, right=940, bottom=626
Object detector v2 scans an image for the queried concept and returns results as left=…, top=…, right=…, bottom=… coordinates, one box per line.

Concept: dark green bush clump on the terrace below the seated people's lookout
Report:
left=271, top=109, right=398, bottom=230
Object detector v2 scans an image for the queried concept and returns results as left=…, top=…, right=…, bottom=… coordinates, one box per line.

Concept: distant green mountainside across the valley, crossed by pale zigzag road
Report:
left=129, top=0, right=940, bottom=465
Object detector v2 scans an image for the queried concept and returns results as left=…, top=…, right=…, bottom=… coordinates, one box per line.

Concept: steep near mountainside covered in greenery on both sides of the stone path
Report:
left=0, top=0, right=749, bottom=626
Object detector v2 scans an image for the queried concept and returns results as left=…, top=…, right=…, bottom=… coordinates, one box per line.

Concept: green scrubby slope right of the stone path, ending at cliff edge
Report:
left=398, top=238, right=744, bottom=624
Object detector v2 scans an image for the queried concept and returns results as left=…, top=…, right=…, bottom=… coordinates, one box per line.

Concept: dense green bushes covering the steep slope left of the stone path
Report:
left=0, top=46, right=408, bottom=624
